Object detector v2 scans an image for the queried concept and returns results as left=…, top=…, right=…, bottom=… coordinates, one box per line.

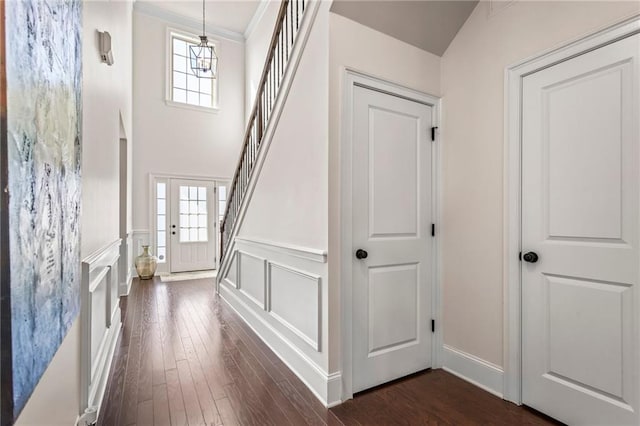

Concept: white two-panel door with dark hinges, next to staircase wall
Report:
left=352, top=87, right=432, bottom=392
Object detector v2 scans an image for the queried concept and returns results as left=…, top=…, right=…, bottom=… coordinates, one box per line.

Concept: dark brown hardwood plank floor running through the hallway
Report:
left=99, top=278, right=553, bottom=426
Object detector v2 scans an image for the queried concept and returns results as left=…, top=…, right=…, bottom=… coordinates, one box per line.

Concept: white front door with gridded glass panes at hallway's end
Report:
left=169, top=179, right=218, bottom=272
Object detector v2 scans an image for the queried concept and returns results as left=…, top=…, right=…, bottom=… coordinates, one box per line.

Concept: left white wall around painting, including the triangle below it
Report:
left=17, top=2, right=132, bottom=426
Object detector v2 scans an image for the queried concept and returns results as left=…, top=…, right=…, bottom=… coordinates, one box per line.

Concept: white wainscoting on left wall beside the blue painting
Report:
left=80, top=239, right=122, bottom=422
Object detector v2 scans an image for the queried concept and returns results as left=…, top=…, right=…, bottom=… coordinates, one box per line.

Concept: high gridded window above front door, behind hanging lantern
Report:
left=167, top=31, right=218, bottom=109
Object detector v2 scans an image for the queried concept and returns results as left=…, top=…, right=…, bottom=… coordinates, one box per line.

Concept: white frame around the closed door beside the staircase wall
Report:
left=340, top=69, right=442, bottom=401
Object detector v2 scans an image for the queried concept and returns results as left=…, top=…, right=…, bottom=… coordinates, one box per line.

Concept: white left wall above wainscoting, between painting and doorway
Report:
left=81, top=2, right=133, bottom=257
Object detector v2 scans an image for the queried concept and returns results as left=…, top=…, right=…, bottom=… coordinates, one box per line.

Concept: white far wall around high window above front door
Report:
left=133, top=11, right=244, bottom=230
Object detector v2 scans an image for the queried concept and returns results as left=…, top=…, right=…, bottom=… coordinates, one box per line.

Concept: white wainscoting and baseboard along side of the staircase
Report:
left=218, top=238, right=342, bottom=406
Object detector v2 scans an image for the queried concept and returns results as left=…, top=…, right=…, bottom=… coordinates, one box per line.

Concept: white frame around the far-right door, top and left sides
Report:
left=503, top=15, right=640, bottom=404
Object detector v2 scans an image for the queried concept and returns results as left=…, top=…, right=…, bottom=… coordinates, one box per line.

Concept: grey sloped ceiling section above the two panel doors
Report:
left=331, top=0, right=478, bottom=56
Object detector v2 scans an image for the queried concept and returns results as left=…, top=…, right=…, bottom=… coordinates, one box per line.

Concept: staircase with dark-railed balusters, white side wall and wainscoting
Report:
left=215, top=0, right=342, bottom=406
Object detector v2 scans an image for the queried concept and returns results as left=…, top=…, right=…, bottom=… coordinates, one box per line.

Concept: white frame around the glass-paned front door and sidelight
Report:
left=148, top=173, right=230, bottom=275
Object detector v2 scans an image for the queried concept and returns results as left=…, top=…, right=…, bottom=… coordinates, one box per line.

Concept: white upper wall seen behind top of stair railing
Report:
left=244, top=0, right=280, bottom=117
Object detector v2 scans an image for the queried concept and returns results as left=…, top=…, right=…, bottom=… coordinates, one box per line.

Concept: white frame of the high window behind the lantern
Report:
left=165, top=27, right=220, bottom=113
